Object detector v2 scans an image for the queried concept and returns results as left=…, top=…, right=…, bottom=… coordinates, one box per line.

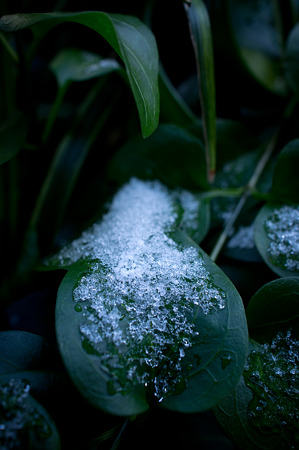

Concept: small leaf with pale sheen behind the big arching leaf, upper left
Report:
left=50, top=48, right=121, bottom=87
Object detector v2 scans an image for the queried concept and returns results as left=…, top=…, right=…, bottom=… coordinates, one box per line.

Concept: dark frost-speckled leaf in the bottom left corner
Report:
left=0, top=377, right=60, bottom=450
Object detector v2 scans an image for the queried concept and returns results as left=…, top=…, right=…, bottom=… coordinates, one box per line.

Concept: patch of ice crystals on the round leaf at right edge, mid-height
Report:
left=265, top=206, right=299, bottom=271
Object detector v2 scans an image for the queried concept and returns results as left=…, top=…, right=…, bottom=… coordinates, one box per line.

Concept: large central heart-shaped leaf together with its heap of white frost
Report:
left=56, top=177, right=247, bottom=415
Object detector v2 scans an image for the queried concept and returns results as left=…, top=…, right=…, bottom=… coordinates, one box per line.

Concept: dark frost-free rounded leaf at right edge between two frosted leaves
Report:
left=246, top=277, right=299, bottom=341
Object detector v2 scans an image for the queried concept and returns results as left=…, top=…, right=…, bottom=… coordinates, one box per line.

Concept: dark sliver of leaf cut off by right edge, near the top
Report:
left=284, top=24, right=299, bottom=94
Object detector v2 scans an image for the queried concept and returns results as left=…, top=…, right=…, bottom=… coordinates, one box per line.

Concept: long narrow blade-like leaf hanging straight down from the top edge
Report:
left=184, top=0, right=216, bottom=181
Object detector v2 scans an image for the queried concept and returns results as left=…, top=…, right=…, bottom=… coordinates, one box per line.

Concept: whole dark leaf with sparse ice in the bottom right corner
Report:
left=214, top=331, right=299, bottom=450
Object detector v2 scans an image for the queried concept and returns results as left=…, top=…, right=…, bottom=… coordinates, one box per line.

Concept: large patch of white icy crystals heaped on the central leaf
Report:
left=55, top=179, right=225, bottom=400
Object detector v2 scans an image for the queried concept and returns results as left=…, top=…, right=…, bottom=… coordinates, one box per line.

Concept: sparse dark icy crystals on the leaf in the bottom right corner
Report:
left=244, top=330, right=299, bottom=449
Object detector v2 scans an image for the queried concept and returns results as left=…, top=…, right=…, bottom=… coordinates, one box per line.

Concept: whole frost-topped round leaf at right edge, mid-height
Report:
left=254, top=204, right=299, bottom=277
